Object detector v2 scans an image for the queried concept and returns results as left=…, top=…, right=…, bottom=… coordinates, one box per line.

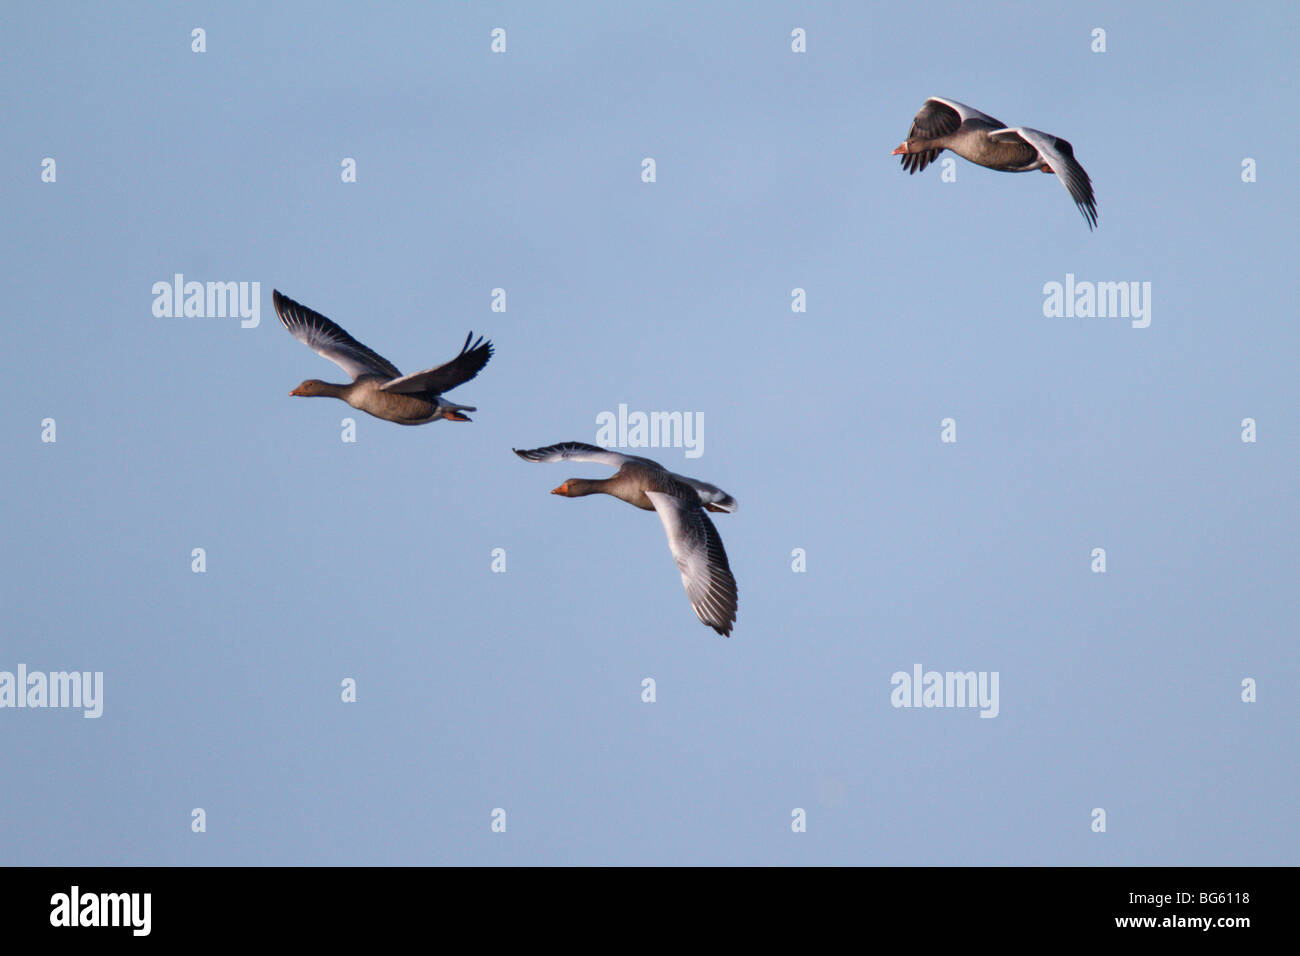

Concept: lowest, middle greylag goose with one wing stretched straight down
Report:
left=512, top=441, right=738, bottom=637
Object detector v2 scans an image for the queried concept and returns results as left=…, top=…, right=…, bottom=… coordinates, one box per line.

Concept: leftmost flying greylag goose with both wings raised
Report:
left=270, top=290, right=493, bottom=425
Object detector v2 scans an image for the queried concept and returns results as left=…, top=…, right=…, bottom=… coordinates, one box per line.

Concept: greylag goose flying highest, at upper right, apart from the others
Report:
left=891, top=96, right=1097, bottom=229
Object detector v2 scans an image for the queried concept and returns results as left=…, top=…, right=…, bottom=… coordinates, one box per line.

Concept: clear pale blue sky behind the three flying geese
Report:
left=0, top=3, right=1300, bottom=865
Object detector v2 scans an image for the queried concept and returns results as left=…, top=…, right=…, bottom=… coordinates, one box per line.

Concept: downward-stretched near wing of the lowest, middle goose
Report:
left=646, top=492, right=740, bottom=637
